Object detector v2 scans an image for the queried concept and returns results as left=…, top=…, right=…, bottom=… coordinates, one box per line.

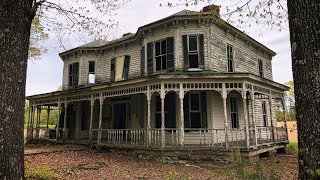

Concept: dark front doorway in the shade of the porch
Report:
left=113, top=103, right=127, bottom=129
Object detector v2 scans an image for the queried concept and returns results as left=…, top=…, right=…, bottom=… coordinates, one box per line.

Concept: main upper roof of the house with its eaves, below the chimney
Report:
left=59, top=10, right=276, bottom=57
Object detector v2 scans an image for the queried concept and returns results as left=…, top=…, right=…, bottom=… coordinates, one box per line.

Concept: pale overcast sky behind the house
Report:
left=26, top=0, right=292, bottom=96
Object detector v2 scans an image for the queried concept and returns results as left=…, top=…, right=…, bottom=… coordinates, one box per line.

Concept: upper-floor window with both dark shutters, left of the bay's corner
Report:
left=146, top=37, right=174, bottom=75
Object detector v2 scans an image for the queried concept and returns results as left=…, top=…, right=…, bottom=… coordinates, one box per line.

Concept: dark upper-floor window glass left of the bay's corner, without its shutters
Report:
left=154, top=40, right=167, bottom=71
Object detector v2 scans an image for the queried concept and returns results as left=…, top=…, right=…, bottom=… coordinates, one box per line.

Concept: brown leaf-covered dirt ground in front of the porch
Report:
left=25, top=145, right=298, bottom=179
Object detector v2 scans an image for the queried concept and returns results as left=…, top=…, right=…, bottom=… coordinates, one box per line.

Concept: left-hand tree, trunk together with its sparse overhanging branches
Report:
left=0, top=0, right=127, bottom=179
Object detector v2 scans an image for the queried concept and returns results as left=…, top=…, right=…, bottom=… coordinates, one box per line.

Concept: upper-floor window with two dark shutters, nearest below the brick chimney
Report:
left=182, top=34, right=204, bottom=69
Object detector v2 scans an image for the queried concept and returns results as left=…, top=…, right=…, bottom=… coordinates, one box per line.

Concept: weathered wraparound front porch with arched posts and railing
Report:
left=27, top=73, right=288, bottom=151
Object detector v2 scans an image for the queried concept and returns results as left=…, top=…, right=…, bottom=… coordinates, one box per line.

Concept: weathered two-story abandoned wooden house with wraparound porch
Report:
left=27, top=5, right=288, bottom=153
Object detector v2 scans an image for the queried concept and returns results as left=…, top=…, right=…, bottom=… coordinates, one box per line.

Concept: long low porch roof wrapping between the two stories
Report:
left=26, top=70, right=290, bottom=100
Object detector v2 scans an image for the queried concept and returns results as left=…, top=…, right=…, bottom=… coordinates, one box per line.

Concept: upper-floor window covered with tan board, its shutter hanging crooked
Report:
left=110, top=56, right=130, bottom=81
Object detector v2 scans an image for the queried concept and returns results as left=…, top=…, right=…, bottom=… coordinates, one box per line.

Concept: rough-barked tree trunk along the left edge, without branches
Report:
left=0, top=0, right=32, bottom=180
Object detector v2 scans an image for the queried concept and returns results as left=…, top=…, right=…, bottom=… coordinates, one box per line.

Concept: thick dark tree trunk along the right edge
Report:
left=287, top=0, right=320, bottom=179
